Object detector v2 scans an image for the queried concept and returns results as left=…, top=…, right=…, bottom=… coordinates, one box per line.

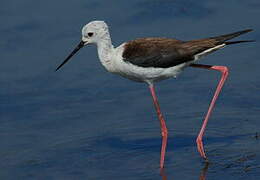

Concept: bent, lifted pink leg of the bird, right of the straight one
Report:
left=190, top=64, right=228, bottom=159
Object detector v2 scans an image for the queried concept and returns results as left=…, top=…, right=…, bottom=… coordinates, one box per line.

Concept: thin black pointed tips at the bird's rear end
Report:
left=211, top=29, right=253, bottom=44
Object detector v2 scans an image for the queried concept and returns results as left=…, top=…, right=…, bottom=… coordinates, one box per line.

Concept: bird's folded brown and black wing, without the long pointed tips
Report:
left=123, top=38, right=193, bottom=68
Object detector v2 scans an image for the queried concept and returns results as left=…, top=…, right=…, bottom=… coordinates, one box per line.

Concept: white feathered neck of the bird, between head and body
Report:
left=97, top=32, right=114, bottom=72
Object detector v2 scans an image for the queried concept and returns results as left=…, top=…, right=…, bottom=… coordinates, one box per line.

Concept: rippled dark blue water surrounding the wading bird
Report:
left=0, top=0, right=260, bottom=180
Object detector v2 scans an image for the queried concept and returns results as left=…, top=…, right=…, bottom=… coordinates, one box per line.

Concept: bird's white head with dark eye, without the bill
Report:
left=82, top=21, right=110, bottom=45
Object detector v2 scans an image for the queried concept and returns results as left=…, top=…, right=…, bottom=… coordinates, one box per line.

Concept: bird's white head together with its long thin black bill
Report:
left=56, top=21, right=111, bottom=71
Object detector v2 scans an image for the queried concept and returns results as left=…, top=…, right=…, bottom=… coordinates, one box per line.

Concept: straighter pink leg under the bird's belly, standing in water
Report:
left=149, top=84, right=168, bottom=169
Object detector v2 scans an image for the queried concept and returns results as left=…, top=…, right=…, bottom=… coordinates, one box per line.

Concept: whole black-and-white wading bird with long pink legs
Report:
left=56, top=20, right=254, bottom=169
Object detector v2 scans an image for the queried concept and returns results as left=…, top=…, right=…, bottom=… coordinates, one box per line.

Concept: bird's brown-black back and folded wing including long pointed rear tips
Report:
left=122, top=29, right=254, bottom=68
